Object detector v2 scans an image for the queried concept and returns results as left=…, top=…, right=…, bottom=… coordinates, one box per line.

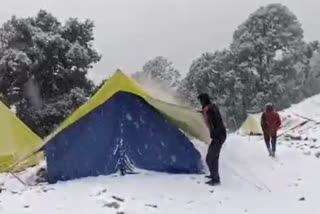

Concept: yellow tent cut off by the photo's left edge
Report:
left=0, top=101, right=42, bottom=172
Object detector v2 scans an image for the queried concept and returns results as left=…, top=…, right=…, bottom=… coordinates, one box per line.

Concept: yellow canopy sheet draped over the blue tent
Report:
left=11, top=70, right=210, bottom=171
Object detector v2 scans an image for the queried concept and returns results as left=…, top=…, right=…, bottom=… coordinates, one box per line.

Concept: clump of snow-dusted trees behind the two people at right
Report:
left=178, top=4, right=320, bottom=128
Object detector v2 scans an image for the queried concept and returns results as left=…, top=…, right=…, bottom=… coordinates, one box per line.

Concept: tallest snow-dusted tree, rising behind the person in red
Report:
left=230, top=4, right=318, bottom=110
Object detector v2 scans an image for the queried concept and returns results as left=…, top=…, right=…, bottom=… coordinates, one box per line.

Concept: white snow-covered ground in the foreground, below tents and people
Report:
left=0, top=135, right=320, bottom=214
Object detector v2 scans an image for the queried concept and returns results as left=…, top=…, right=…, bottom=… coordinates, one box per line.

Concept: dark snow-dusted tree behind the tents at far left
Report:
left=0, top=10, right=100, bottom=136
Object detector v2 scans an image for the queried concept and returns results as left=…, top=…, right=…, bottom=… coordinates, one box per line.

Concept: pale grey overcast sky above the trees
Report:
left=0, top=0, right=320, bottom=81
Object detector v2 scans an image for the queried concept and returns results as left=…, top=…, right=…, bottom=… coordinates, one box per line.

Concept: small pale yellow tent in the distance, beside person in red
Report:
left=239, top=113, right=263, bottom=135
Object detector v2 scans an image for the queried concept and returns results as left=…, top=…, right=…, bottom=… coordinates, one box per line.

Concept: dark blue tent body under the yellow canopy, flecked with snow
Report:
left=44, top=91, right=203, bottom=183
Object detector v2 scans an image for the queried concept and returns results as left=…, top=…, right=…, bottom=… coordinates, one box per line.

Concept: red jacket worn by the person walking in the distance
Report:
left=261, top=111, right=281, bottom=137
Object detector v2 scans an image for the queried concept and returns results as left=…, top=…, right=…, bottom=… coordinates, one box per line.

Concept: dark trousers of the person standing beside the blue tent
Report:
left=206, top=139, right=225, bottom=181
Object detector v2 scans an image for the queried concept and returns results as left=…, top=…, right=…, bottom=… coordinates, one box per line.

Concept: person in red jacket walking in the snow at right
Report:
left=261, top=103, right=281, bottom=157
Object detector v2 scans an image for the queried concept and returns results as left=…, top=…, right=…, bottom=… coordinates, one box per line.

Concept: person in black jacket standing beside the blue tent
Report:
left=198, top=94, right=227, bottom=185
